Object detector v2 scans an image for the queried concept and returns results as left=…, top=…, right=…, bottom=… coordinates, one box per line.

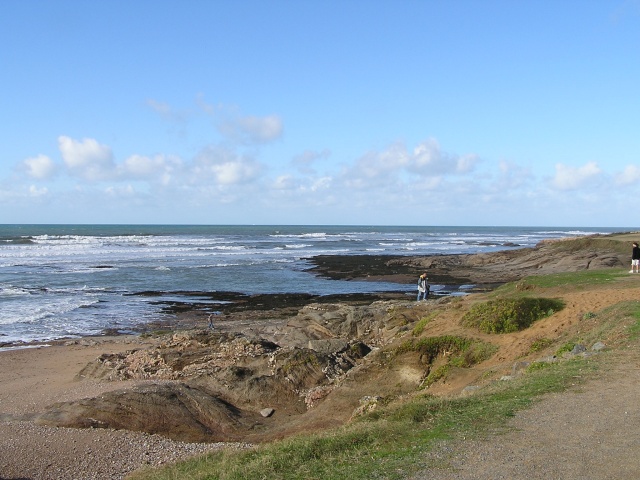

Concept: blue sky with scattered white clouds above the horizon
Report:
left=0, top=0, right=640, bottom=228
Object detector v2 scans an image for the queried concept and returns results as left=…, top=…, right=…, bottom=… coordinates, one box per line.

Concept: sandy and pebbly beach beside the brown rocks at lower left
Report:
left=0, top=336, right=245, bottom=480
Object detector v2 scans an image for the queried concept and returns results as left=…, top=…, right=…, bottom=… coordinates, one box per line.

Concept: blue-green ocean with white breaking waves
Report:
left=0, top=225, right=629, bottom=343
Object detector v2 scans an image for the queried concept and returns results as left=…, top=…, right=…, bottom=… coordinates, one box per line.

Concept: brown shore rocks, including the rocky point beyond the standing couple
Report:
left=28, top=238, right=628, bottom=441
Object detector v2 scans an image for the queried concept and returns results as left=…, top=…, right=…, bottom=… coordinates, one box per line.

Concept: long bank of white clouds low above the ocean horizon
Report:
left=7, top=102, right=640, bottom=225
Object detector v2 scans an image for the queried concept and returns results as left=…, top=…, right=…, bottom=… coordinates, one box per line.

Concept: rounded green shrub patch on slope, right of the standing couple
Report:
left=462, top=297, right=564, bottom=333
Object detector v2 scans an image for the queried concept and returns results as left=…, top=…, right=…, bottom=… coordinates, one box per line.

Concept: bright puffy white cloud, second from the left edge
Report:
left=58, top=135, right=116, bottom=181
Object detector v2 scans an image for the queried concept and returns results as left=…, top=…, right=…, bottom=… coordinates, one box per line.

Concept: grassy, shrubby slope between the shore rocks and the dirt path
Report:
left=129, top=260, right=640, bottom=480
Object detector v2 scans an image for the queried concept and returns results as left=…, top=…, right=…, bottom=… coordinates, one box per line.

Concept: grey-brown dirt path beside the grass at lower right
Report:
left=412, top=350, right=640, bottom=480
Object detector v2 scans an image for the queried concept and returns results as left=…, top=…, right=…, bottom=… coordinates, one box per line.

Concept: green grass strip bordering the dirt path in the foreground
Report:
left=130, top=359, right=598, bottom=480
